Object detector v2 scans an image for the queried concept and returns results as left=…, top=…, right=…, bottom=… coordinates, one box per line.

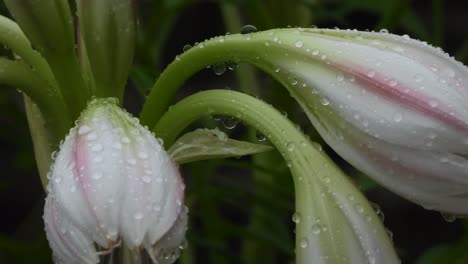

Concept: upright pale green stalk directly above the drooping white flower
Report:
left=76, top=0, right=136, bottom=100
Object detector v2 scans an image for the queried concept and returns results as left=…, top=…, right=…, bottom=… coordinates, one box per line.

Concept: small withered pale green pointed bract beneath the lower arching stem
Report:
left=169, top=129, right=273, bottom=164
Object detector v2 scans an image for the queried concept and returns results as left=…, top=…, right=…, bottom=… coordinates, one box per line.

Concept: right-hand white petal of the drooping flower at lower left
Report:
left=121, top=122, right=183, bottom=246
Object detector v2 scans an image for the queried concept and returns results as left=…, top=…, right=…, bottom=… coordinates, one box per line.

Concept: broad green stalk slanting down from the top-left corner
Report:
left=4, top=0, right=90, bottom=117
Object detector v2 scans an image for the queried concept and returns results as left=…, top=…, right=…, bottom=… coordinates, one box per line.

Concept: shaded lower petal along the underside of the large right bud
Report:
left=311, top=106, right=468, bottom=215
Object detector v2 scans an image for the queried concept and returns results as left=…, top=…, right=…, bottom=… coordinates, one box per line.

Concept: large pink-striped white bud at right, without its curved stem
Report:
left=257, top=29, right=468, bottom=215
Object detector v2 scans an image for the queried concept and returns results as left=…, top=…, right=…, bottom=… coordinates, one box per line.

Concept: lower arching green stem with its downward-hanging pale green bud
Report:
left=153, top=90, right=397, bottom=264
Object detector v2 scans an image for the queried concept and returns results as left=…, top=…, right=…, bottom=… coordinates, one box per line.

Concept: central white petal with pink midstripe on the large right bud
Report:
left=274, top=31, right=468, bottom=154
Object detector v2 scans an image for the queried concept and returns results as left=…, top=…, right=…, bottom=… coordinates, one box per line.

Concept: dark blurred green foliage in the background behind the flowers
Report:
left=0, top=0, right=468, bottom=264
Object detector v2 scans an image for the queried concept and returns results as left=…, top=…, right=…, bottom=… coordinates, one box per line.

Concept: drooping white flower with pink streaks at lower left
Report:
left=44, top=99, right=187, bottom=263
